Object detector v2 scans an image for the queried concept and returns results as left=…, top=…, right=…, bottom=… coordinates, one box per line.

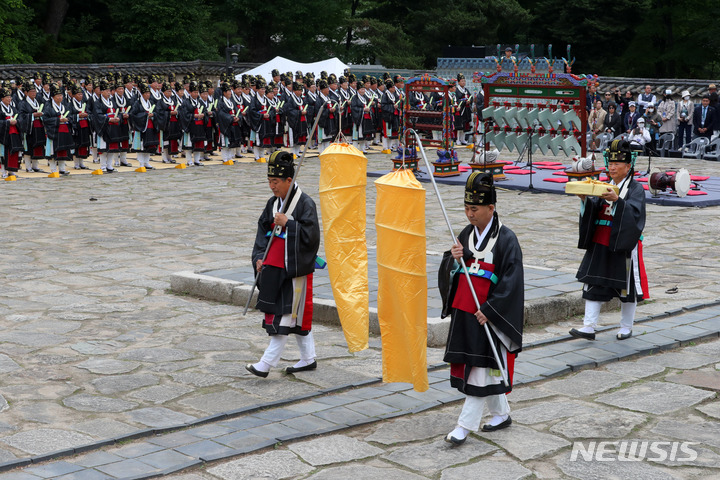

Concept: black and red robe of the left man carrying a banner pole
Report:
left=252, top=186, right=320, bottom=335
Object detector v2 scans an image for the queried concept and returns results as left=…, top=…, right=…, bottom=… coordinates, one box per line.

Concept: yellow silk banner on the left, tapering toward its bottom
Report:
left=320, top=143, right=370, bottom=352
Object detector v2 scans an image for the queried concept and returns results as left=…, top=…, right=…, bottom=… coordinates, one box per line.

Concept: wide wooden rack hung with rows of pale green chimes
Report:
left=470, top=46, right=600, bottom=177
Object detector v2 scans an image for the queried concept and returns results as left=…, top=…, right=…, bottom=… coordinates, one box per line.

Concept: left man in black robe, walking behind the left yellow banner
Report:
left=245, top=150, right=320, bottom=378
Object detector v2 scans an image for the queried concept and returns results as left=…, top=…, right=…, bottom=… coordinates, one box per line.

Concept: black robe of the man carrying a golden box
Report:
left=576, top=173, right=649, bottom=302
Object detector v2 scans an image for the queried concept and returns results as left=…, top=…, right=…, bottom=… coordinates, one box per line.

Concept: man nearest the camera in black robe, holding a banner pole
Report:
left=438, top=172, right=524, bottom=445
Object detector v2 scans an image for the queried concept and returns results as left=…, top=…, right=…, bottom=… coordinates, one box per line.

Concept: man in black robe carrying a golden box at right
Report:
left=570, top=140, right=649, bottom=340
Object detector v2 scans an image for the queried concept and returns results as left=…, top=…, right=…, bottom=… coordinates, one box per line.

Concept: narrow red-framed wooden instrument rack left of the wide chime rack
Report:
left=400, top=74, right=461, bottom=177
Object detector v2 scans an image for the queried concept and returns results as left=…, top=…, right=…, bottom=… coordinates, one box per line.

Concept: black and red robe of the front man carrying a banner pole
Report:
left=438, top=218, right=525, bottom=397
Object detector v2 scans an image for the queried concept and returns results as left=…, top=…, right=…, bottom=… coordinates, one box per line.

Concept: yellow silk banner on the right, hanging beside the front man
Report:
left=375, top=169, right=428, bottom=392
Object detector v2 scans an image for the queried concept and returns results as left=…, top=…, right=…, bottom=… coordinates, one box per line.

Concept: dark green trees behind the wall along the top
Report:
left=0, top=0, right=720, bottom=78
